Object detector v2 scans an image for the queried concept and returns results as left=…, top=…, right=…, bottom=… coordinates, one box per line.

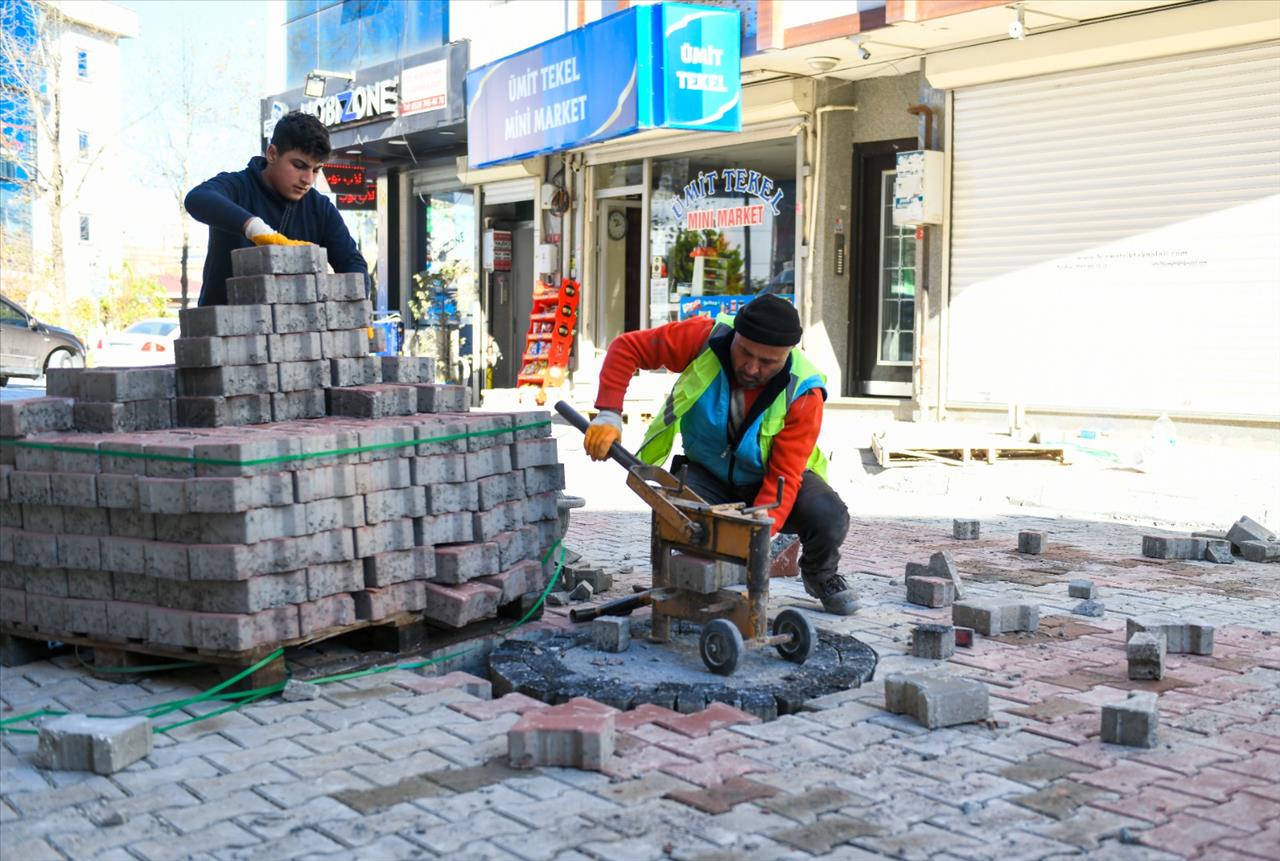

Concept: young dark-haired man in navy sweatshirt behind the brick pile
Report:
left=187, top=111, right=369, bottom=306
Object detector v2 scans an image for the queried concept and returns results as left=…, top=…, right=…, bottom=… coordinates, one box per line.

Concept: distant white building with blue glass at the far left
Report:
left=0, top=0, right=137, bottom=313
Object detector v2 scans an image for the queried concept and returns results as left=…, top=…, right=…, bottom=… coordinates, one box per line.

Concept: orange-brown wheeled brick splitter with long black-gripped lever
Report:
left=556, top=400, right=818, bottom=675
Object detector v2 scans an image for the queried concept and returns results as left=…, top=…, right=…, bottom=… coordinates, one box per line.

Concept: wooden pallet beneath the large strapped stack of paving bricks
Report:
left=0, top=613, right=426, bottom=690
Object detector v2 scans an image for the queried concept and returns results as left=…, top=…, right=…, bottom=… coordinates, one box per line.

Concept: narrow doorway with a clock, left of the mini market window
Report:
left=595, top=198, right=641, bottom=345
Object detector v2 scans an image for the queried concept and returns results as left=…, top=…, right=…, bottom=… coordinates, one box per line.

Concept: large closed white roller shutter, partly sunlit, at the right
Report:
left=947, top=43, right=1280, bottom=417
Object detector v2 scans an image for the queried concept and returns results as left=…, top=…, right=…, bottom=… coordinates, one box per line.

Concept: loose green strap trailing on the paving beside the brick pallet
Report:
left=0, top=539, right=564, bottom=736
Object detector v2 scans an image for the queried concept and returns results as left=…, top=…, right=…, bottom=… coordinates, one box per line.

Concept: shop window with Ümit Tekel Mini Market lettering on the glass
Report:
left=649, top=138, right=796, bottom=324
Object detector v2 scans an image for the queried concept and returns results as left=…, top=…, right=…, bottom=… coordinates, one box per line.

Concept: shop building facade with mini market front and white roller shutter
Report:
left=264, top=0, right=1280, bottom=429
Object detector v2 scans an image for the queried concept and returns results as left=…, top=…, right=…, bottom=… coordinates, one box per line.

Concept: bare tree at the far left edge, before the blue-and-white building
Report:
left=0, top=0, right=68, bottom=306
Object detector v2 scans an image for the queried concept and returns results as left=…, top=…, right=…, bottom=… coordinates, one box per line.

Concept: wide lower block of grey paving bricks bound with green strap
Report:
left=0, top=401, right=564, bottom=651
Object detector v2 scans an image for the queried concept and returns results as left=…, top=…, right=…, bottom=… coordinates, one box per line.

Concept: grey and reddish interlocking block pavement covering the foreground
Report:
left=0, top=414, right=1280, bottom=861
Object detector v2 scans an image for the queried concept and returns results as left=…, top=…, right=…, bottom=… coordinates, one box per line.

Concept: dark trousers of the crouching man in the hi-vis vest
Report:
left=672, top=455, right=849, bottom=578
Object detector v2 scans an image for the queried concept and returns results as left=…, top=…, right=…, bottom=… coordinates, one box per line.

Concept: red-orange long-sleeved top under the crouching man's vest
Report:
left=595, top=317, right=822, bottom=535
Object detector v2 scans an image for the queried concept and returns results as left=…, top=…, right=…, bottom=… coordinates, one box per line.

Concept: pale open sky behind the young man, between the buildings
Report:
left=116, top=0, right=280, bottom=262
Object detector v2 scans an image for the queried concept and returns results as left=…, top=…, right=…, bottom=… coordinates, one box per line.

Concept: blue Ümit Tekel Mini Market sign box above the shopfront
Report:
left=467, top=3, right=742, bottom=168
